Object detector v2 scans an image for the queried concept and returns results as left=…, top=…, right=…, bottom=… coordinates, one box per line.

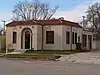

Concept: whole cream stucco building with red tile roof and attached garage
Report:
left=6, top=19, right=93, bottom=50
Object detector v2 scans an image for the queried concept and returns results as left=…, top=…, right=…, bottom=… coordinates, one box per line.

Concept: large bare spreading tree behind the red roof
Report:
left=12, top=0, right=58, bottom=21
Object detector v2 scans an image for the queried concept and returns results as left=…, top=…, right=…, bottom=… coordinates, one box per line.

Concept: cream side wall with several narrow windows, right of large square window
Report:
left=62, top=25, right=82, bottom=50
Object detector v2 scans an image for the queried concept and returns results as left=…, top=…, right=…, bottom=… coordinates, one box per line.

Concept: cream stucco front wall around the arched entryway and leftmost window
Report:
left=6, top=25, right=37, bottom=50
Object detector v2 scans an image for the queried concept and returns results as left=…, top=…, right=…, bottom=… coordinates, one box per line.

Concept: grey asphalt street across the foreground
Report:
left=0, top=58, right=100, bottom=75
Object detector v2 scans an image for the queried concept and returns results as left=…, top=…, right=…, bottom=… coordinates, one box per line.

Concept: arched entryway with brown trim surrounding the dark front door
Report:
left=21, top=28, right=32, bottom=49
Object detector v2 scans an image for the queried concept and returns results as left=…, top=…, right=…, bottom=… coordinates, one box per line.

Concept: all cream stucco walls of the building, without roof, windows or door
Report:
left=6, top=25, right=93, bottom=50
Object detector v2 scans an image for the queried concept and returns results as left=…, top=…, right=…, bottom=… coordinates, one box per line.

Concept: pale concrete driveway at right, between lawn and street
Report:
left=59, top=52, right=100, bottom=64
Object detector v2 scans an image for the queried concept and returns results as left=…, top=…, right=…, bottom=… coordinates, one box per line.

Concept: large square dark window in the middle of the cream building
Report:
left=46, top=31, right=54, bottom=44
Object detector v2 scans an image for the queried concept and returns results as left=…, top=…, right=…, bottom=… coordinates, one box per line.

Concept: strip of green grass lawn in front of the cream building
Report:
left=5, top=50, right=83, bottom=59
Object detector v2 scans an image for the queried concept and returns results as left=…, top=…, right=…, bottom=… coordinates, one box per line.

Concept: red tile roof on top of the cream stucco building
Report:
left=6, top=19, right=82, bottom=28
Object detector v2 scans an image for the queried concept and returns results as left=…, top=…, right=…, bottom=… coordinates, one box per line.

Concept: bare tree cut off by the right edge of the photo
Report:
left=86, top=3, right=100, bottom=32
